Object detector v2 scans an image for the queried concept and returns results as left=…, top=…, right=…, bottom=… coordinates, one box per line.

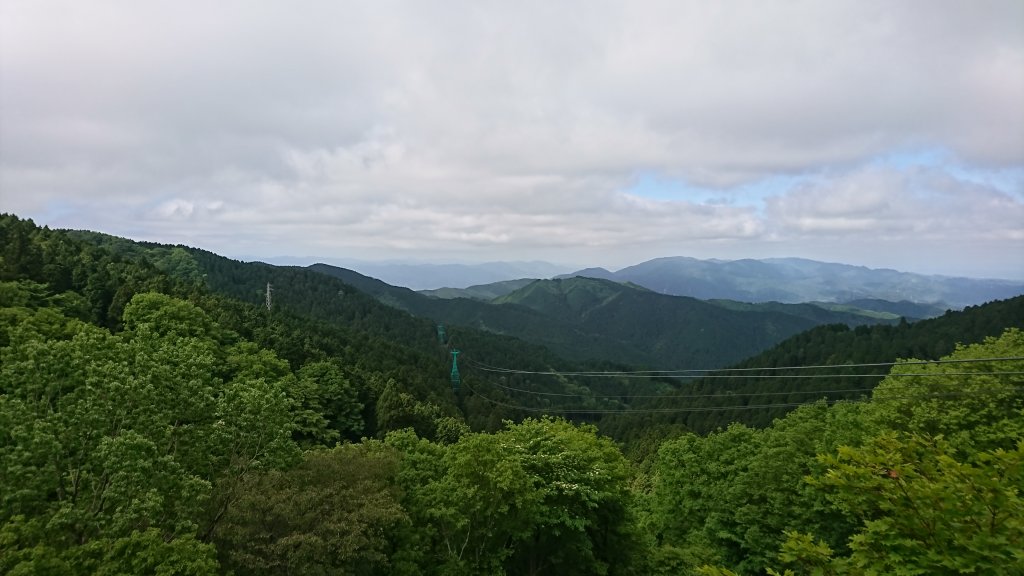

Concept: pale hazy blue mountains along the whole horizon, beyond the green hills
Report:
left=329, top=256, right=1024, bottom=307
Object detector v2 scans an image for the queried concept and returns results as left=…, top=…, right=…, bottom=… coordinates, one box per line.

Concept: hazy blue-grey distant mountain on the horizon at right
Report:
left=559, top=256, right=1024, bottom=308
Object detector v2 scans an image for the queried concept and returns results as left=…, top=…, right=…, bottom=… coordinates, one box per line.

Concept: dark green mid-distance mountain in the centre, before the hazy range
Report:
left=310, top=264, right=913, bottom=368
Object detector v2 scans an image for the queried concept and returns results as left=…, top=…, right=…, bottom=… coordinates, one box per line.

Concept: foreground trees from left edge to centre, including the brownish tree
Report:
left=0, top=282, right=634, bottom=574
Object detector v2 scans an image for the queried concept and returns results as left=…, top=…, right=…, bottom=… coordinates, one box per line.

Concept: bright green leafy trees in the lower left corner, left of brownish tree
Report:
left=0, top=294, right=296, bottom=573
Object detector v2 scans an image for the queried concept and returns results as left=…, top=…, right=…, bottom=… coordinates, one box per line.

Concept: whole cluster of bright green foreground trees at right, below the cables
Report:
left=645, top=329, right=1024, bottom=574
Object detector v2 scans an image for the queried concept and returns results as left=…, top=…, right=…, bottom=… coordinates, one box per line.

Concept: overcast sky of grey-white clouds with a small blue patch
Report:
left=0, top=0, right=1024, bottom=279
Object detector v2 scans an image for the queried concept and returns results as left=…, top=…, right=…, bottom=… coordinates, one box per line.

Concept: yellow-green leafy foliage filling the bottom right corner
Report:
left=816, top=433, right=1024, bottom=574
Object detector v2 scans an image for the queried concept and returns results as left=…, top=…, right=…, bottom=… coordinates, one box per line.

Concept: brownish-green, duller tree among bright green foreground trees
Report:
left=215, top=441, right=409, bottom=575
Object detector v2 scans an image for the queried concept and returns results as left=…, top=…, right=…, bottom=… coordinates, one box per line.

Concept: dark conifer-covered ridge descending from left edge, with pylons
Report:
left=18, top=216, right=647, bottom=426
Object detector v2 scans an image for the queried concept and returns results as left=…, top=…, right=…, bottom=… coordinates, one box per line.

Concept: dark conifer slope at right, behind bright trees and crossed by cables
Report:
left=602, top=296, right=1024, bottom=438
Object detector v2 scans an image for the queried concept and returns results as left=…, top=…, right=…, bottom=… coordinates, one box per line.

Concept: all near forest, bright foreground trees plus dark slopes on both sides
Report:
left=0, top=215, right=1024, bottom=575
